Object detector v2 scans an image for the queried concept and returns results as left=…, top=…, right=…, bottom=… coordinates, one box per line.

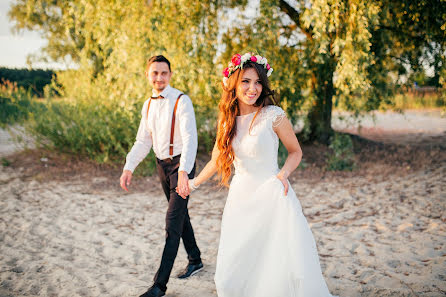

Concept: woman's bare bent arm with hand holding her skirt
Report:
left=274, top=117, right=302, bottom=195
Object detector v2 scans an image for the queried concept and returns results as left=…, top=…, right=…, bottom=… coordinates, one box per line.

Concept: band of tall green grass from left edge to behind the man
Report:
left=0, top=82, right=215, bottom=175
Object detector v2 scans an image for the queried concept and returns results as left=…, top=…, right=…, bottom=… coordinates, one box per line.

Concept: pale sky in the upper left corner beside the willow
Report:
left=0, top=0, right=66, bottom=69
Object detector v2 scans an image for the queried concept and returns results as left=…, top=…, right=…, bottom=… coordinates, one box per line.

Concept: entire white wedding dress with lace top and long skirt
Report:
left=215, top=106, right=331, bottom=297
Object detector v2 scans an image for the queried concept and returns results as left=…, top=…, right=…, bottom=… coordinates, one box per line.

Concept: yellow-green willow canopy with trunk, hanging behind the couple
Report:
left=9, top=0, right=446, bottom=143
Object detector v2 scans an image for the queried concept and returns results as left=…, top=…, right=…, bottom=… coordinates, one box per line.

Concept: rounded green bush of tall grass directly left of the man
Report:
left=27, top=98, right=159, bottom=175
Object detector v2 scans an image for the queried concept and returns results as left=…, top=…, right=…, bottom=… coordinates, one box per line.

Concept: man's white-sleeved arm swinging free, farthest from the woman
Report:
left=120, top=101, right=153, bottom=191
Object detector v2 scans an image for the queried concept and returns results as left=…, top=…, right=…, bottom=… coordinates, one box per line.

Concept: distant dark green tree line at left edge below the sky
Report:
left=0, top=67, right=54, bottom=97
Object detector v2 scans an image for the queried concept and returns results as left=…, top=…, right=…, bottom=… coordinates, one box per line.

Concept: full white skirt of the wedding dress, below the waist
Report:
left=215, top=174, right=331, bottom=297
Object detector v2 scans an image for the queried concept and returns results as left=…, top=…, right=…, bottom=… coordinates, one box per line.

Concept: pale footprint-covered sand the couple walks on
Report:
left=0, top=110, right=446, bottom=297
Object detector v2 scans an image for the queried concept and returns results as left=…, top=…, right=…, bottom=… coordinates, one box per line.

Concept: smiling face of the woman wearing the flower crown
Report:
left=236, top=68, right=263, bottom=105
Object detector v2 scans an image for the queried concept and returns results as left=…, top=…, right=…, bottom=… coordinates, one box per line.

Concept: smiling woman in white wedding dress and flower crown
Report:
left=177, top=53, right=331, bottom=297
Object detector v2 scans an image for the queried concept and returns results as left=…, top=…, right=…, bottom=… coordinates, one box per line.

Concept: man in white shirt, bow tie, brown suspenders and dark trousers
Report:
left=120, top=55, right=203, bottom=297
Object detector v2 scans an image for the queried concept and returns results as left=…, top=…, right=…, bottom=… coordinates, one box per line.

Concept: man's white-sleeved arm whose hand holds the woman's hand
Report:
left=178, top=95, right=198, bottom=197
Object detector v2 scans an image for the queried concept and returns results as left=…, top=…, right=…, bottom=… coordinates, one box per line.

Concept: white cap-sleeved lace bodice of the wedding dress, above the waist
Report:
left=232, top=105, right=285, bottom=176
